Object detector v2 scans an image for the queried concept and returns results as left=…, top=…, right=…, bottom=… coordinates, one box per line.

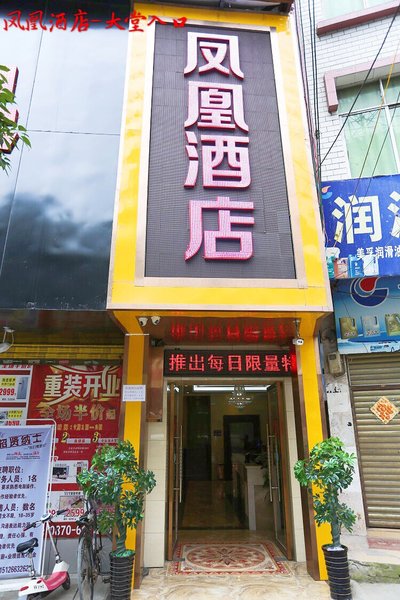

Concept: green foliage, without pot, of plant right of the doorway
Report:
left=294, top=437, right=356, bottom=548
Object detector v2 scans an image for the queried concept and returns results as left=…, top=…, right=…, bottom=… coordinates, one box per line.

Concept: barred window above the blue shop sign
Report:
left=338, top=76, right=400, bottom=177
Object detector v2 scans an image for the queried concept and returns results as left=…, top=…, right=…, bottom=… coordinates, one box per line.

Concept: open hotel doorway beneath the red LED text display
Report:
left=167, top=380, right=293, bottom=560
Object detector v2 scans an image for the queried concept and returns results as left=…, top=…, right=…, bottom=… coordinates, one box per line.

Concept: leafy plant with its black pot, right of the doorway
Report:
left=294, top=437, right=356, bottom=600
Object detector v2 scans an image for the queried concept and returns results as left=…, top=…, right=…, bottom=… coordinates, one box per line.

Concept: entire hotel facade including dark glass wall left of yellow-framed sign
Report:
left=0, top=1, right=340, bottom=584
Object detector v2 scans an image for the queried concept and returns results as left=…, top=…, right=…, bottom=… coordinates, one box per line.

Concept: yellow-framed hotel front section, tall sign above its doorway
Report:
left=107, top=2, right=331, bottom=578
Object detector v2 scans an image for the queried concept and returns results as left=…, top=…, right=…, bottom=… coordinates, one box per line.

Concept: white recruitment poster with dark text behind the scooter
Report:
left=0, top=425, right=54, bottom=579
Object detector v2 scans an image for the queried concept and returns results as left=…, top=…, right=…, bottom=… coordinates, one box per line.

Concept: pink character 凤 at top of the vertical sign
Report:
left=184, top=31, right=244, bottom=79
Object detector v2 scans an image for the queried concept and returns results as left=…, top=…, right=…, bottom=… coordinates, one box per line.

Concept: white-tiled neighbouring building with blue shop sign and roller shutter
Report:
left=296, top=0, right=400, bottom=562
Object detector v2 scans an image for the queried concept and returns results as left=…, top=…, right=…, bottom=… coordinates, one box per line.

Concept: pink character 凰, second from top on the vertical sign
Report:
left=185, top=81, right=249, bottom=133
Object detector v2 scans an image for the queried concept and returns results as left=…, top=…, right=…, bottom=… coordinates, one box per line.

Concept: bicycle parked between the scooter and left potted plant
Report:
left=77, top=498, right=108, bottom=600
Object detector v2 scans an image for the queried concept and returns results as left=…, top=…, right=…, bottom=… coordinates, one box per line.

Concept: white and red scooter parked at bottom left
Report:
left=17, top=508, right=71, bottom=600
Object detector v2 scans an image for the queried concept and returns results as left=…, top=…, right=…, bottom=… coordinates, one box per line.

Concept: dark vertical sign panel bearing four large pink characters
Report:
left=145, top=25, right=296, bottom=285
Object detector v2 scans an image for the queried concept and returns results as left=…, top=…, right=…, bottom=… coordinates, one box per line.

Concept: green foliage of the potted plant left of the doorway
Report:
left=77, top=440, right=156, bottom=556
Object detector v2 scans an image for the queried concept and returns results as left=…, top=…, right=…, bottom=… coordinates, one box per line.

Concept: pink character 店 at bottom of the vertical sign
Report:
left=185, top=196, right=254, bottom=260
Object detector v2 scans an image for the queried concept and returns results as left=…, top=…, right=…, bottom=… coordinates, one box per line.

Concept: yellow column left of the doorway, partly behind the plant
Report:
left=122, top=334, right=149, bottom=571
